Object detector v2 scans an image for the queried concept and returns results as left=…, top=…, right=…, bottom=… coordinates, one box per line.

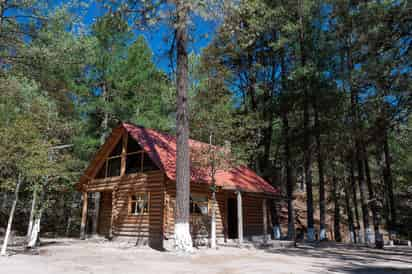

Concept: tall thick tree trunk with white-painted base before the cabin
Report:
left=175, top=0, right=193, bottom=252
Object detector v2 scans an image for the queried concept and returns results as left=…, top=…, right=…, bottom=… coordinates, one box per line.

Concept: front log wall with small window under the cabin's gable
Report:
left=87, top=170, right=164, bottom=246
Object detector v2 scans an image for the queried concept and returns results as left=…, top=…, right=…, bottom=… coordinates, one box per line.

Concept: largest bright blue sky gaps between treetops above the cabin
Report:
left=78, top=0, right=218, bottom=72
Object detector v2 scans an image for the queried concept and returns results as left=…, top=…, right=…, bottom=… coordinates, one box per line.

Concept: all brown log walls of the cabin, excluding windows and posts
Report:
left=87, top=170, right=270, bottom=245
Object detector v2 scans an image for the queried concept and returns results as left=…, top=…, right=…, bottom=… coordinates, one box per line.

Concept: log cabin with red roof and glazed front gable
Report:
left=78, top=123, right=279, bottom=248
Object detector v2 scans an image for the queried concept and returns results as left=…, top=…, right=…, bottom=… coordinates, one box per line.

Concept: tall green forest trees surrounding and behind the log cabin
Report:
left=0, top=0, right=412, bottom=253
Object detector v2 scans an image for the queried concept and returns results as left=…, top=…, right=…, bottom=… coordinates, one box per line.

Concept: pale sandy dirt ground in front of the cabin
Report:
left=0, top=239, right=412, bottom=274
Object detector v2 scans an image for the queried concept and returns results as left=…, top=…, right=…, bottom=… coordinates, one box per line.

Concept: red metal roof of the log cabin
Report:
left=121, top=123, right=279, bottom=194
